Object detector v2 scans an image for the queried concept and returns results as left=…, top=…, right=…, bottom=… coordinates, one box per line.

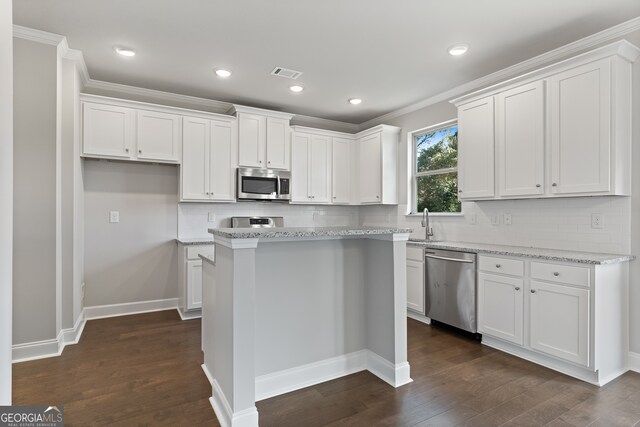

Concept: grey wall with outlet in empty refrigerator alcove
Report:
left=84, top=160, right=178, bottom=307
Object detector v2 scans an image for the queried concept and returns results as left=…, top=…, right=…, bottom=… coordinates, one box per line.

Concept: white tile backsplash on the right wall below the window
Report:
left=360, top=196, right=631, bottom=253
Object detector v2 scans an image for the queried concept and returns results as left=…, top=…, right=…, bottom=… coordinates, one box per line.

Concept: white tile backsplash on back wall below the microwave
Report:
left=178, top=202, right=360, bottom=239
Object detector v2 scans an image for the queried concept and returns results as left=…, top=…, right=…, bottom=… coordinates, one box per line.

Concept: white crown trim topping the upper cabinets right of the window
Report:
left=449, top=40, right=640, bottom=106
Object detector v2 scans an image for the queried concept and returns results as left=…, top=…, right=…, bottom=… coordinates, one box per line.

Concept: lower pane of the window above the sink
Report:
left=416, top=172, right=461, bottom=212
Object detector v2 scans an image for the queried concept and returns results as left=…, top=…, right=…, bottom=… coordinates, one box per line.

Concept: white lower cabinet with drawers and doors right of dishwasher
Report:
left=478, top=255, right=629, bottom=385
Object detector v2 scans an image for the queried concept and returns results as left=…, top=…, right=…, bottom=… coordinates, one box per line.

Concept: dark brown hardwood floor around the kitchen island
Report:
left=13, top=311, right=640, bottom=427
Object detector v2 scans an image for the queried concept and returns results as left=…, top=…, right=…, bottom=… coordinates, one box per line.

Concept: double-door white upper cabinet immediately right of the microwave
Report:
left=291, top=132, right=331, bottom=204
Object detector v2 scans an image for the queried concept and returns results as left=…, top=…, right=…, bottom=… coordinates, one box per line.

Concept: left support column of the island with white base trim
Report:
left=202, top=236, right=258, bottom=427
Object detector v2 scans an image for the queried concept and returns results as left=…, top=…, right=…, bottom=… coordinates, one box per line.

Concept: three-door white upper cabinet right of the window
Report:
left=451, top=40, right=640, bottom=200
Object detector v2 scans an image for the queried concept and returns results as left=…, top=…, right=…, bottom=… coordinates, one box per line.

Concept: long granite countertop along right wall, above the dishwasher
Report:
left=407, top=240, right=636, bottom=264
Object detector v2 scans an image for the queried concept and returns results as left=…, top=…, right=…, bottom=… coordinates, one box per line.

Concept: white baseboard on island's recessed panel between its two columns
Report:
left=256, top=350, right=367, bottom=401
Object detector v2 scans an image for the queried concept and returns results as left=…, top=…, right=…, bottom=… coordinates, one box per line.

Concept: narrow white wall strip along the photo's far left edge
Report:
left=0, top=1, right=13, bottom=405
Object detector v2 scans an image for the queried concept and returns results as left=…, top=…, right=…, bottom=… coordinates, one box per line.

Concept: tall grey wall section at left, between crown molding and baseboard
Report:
left=13, top=38, right=58, bottom=344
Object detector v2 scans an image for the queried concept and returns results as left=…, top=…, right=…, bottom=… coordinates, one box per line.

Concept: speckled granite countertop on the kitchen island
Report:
left=209, top=227, right=413, bottom=239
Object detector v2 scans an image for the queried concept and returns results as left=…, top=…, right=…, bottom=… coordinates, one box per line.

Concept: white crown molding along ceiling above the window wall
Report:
left=360, top=16, right=640, bottom=129
